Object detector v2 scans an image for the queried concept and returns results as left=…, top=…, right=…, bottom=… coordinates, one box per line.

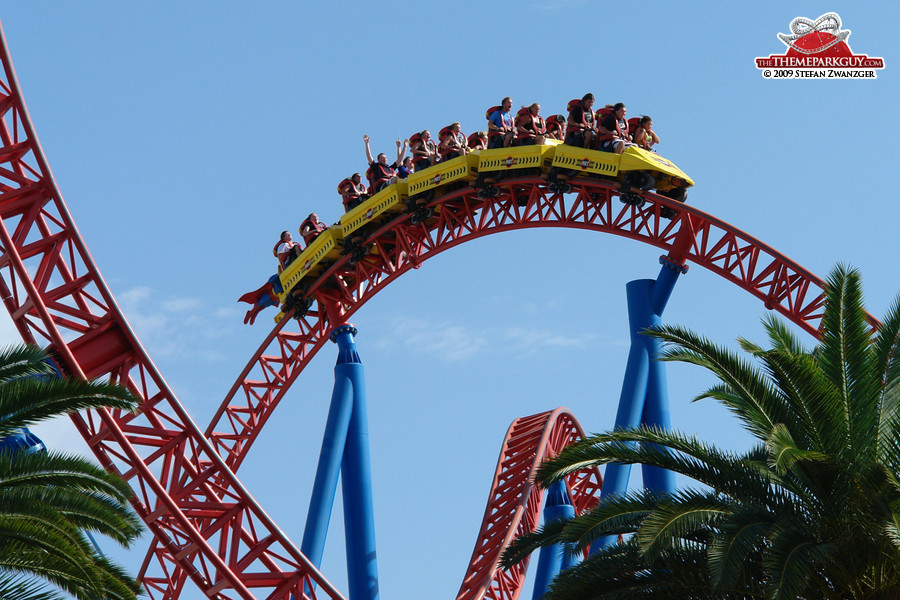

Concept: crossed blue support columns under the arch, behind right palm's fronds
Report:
left=591, top=257, right=684, bottom=551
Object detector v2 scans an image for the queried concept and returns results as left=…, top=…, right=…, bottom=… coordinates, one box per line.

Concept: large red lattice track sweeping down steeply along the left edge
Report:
left=0, top=22, right=342, bottom=600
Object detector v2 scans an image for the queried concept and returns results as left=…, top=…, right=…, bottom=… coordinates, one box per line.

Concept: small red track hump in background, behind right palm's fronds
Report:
left=456, top=408, right=602, bottom=600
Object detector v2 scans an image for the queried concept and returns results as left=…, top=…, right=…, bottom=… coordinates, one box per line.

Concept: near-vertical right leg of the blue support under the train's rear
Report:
left=339, top=328, right=378, bottom=600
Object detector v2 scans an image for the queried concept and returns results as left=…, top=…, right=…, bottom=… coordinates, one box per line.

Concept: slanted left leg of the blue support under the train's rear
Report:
left=300, top=327, right=362, bottom=568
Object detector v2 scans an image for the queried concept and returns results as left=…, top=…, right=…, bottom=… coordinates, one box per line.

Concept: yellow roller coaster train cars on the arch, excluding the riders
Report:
left=275, top=139, right=694, bottom=323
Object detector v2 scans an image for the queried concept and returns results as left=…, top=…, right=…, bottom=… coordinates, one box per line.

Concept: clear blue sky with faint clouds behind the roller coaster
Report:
left=0, top=0, right=900, bottom=598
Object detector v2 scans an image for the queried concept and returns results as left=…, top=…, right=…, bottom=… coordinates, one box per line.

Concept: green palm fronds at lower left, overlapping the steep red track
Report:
left=0, top=346, right=142, bottom=600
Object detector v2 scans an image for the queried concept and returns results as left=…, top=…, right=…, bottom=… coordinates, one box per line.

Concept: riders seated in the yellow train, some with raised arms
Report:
left=242, top=94, right=659, bottom=323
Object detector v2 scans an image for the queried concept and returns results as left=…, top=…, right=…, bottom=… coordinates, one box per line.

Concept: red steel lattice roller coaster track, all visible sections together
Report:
left=0, top=21, right=823, bottom=600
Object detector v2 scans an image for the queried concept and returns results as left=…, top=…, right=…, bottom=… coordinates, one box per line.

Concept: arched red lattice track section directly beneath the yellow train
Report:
left=144, top=178, right=823, bottom=598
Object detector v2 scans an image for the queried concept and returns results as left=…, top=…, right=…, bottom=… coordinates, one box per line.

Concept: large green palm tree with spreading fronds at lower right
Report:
left=504, top=266, right=900, bottom=600
